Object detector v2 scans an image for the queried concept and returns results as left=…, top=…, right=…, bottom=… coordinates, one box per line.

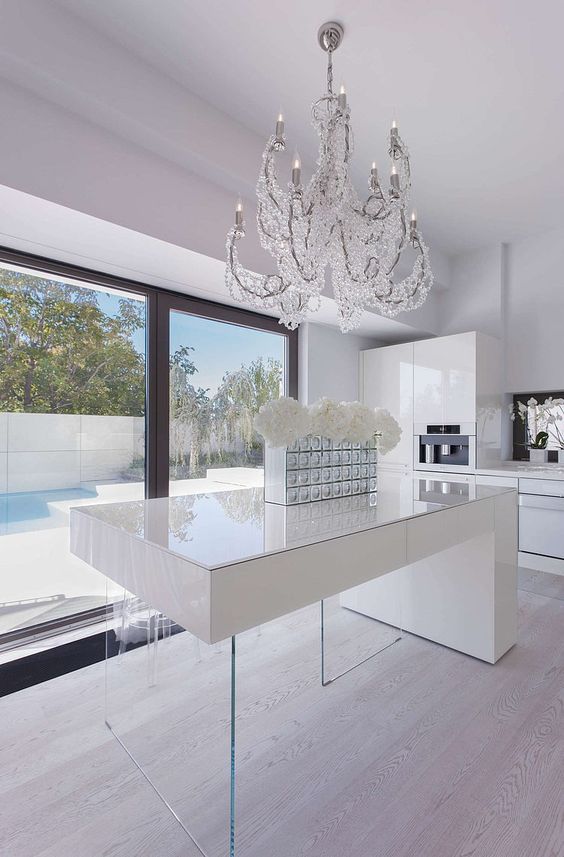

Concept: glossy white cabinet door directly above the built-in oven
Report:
left=413, top=332, right=476, bottom=425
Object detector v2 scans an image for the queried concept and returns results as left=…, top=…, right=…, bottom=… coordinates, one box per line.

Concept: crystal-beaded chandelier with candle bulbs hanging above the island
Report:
left=226, top=22, right=433, bottom=333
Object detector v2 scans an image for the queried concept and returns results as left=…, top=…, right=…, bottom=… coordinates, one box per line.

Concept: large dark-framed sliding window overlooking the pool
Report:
left=0, top=251, right=297, bottom=650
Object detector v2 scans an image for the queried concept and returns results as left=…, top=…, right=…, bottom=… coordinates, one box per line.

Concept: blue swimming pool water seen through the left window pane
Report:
left=0, top=488, right=97, bottom=534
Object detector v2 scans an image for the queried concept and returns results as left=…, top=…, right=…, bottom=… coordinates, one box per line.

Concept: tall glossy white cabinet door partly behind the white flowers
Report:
left=360, top=342, right=413, bottom=467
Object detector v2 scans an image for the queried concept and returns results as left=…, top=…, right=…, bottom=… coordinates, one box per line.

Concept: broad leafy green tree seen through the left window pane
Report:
left=0, top=268, right=145, bottom=416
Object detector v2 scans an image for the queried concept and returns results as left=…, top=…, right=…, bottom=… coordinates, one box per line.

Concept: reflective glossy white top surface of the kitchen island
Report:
left=71, top=473, right=512, bottom=571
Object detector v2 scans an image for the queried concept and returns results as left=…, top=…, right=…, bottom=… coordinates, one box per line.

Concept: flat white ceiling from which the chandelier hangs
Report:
left=57, top=0, right=564, bottom=254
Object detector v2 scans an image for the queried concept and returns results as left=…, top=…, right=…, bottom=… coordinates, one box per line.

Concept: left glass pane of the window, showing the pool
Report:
left=0, top=265, right=145, bottom=640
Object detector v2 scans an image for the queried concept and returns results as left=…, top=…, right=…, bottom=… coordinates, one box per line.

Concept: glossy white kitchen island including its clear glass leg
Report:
left=71, top=474, right=517, bottom=857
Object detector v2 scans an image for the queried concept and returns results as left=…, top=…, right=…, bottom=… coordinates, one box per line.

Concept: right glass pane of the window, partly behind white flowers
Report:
left=169, top=311, right=286, bottom=494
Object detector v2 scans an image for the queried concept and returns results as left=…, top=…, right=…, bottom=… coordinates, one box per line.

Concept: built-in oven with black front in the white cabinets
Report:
left=413, top=423, right=476, bottom=473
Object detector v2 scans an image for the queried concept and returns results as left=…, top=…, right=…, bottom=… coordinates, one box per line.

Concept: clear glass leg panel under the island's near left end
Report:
left=105, top=584, right=233, bottom=857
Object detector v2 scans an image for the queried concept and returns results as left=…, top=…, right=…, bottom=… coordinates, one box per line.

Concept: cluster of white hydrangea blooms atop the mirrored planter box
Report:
left=255, top=396, right=401, bottom=453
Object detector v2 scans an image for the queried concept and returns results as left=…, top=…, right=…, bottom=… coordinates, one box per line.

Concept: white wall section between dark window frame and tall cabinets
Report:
left=299, top=323, right=382, bottom=404
